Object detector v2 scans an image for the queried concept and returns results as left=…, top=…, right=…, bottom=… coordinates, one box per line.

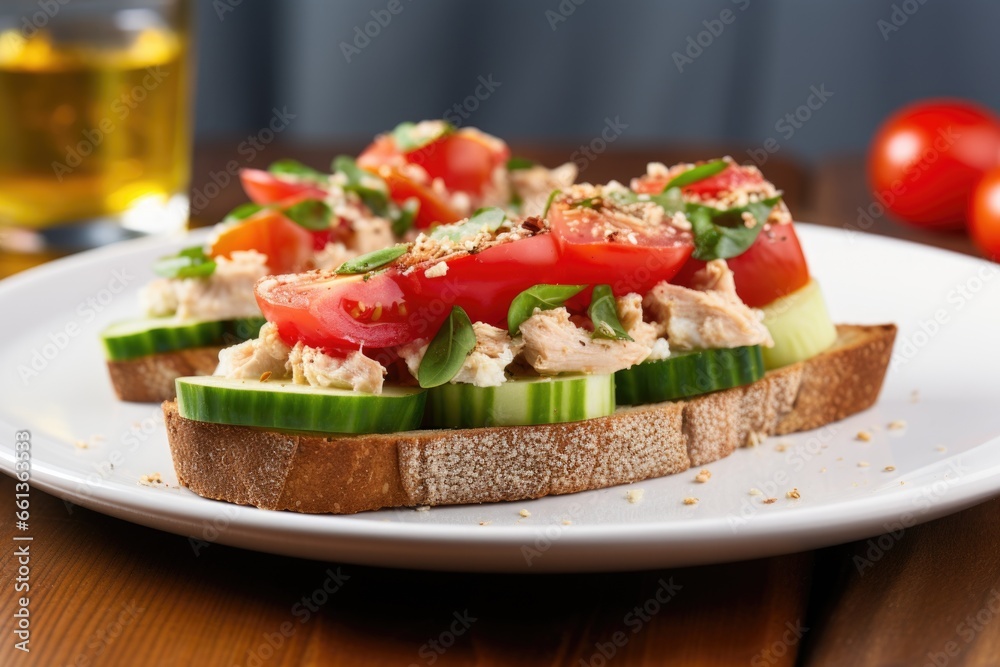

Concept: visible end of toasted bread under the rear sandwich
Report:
left=108, top=345, right=223, bottom=403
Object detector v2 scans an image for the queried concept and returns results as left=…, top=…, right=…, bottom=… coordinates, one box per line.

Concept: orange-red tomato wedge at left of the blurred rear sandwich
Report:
left=209, top=208, right=315, bottom=273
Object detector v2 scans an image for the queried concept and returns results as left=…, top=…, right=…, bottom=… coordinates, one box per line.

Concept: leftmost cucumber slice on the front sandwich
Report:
left=177, top=376, right=427, bottom=433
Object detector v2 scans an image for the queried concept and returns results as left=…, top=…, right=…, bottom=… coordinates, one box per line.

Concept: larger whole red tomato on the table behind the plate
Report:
left=868, top=100, right=1000, bottom=229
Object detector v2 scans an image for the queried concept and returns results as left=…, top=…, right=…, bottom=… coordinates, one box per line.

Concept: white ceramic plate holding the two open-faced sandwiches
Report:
left=0, top=225, right=1000, bottom=571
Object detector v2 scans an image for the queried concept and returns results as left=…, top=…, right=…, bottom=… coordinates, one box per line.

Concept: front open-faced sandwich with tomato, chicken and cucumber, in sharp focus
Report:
left=163, top=159, right=895, bottom=513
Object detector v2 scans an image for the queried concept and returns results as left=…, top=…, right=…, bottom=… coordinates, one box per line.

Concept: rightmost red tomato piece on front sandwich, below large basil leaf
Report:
left=675, top=223, right=809, bottom=308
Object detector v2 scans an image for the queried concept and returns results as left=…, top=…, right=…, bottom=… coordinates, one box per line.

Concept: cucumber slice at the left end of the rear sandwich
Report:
left=101, top=317, right=265, bottom=361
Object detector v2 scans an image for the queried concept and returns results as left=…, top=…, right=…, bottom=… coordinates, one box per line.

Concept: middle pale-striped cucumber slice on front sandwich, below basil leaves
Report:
left=427, top=375, right=615, bottom=428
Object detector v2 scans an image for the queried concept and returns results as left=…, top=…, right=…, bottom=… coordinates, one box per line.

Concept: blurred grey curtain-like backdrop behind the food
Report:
left=197, top=0, right=1000, bottom=160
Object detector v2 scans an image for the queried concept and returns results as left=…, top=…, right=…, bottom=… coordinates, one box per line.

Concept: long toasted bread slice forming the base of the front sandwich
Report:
left=163, top=325, right=896, bottom=514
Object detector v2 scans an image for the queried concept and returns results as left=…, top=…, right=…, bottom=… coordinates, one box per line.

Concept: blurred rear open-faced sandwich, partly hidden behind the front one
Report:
left=102, top=121, right=576, bottom=401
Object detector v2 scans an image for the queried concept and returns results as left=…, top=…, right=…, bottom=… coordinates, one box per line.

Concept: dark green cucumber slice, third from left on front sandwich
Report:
left=615, top=345, right=764, bottom=405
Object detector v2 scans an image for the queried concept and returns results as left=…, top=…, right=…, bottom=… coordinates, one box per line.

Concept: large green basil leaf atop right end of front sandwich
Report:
left=686, top=196, right=781, bottom=262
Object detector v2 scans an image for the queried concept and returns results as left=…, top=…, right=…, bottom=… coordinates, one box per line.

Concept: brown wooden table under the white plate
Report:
left=0, top=141, right=1000, bottom=667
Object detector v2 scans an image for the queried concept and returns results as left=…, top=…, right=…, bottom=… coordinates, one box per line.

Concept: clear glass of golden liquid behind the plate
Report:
left=0, top=0, right=193, bottom=276
